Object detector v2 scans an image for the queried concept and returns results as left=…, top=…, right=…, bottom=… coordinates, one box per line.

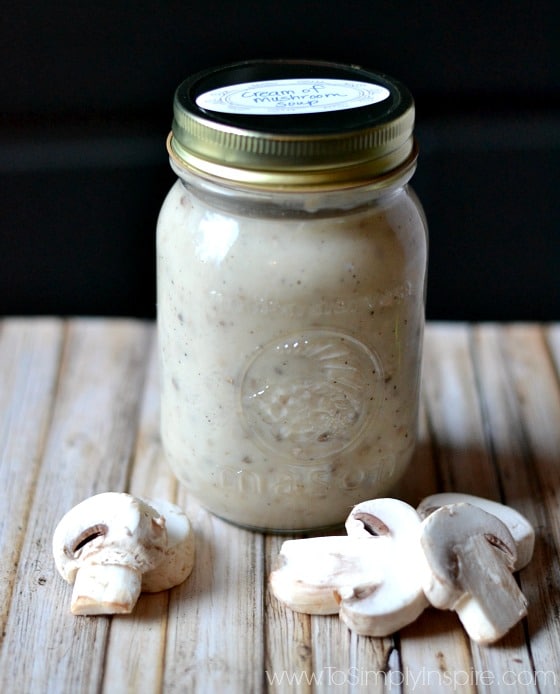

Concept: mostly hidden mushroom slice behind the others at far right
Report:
left=417, top=492, right=535, bottom=571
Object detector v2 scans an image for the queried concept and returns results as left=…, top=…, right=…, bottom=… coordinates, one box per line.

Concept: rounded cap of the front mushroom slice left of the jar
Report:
left=52, top=492, right=167, bottom=583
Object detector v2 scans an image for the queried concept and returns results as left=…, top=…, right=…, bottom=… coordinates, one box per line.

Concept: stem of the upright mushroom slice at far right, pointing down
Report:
left=453, top=535, right=527, bottom=643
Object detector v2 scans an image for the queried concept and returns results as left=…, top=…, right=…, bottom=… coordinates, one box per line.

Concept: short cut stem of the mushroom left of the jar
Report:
left=70, top=564, right=142, bottom=615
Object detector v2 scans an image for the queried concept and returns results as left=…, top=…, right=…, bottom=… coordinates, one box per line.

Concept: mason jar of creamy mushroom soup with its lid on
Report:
left=157, top=61, right=427, bottom=532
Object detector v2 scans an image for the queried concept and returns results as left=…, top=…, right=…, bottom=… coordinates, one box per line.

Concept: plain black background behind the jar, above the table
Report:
left=0, top=0, right=560, bottom=320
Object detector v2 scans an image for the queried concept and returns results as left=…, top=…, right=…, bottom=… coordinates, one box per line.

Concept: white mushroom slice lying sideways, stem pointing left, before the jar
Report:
left=270, top=499, right=428, bottom=636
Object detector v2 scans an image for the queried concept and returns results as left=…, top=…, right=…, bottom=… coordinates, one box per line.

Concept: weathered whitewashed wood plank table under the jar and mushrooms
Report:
left=0, top=319, right=560, bottom=694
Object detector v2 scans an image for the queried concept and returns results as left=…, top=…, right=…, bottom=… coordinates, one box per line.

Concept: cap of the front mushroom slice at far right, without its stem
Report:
left=420, top=502, right=517, bottom=609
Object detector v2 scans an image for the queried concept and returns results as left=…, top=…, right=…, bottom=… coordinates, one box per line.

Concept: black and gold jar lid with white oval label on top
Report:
left=168, top=60, right=417, bottom=190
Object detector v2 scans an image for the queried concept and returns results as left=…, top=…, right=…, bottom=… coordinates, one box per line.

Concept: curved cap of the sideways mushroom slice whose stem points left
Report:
left=340, top=498, right=428, bottom=636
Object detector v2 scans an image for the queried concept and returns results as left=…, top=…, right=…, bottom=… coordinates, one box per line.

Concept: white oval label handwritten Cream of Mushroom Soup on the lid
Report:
left=196, top=78, right=390, bottom=116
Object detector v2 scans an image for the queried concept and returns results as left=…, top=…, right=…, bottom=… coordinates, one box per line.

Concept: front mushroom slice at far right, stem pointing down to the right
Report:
left=420, top=503, right=527, bottom=643
